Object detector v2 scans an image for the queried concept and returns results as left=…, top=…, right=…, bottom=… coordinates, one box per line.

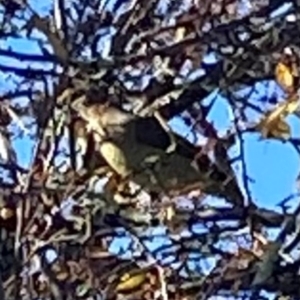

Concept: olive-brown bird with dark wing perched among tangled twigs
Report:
left=72, top=97, right=243, bottom=206
